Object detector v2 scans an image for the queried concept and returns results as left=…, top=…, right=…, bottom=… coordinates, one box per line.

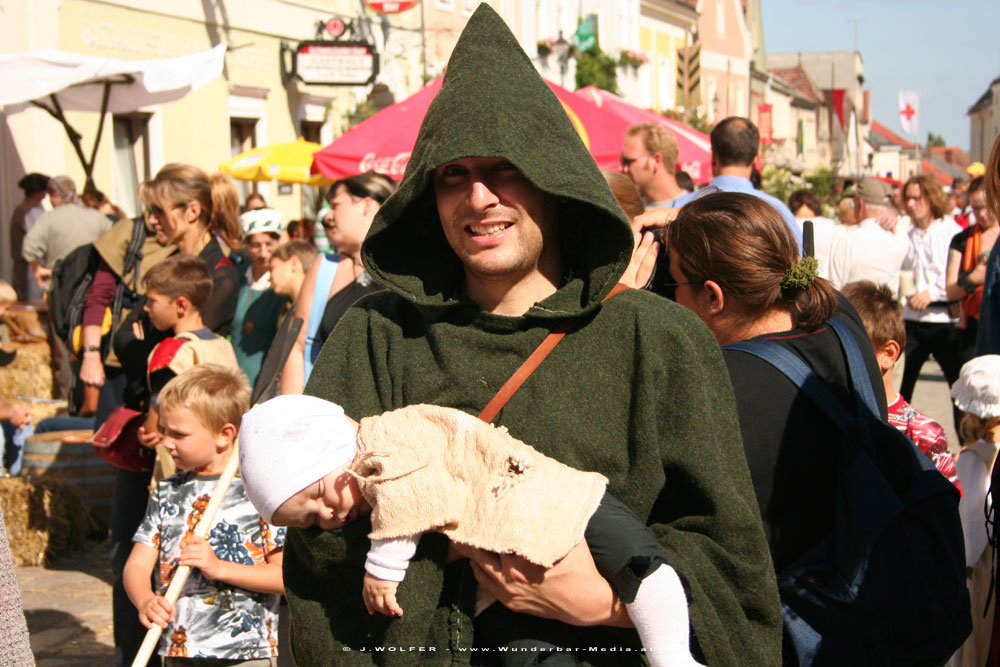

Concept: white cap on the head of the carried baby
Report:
left=240, top=394, right=357, bottom=522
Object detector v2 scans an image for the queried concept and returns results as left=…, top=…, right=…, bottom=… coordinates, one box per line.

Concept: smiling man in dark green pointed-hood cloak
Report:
left=285, top=3, right=781, bottom=665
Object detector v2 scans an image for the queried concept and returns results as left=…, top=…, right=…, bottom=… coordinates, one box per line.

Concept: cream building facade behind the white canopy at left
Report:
left=0, top=0, right=426, bottom=282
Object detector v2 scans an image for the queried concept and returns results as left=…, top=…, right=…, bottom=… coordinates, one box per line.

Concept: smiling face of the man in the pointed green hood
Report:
left=434, top=157, right=560, bottom=290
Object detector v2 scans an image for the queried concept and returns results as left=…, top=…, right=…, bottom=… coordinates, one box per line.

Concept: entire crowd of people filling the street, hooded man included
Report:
left=0, top=7, right=1000, bottom=667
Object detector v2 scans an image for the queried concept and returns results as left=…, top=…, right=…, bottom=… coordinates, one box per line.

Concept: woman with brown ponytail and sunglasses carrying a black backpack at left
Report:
left=80, top=164, right=242, bottom=665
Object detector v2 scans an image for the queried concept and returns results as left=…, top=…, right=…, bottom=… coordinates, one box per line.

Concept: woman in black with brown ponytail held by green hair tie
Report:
left=666, top=193, right=964, bottom=665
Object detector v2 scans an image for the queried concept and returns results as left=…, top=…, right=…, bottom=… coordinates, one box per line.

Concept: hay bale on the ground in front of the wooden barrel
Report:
left=0, top=477, right=95, bottom=567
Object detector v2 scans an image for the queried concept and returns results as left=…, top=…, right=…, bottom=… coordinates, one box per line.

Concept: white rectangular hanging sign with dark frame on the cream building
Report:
left=295, top=41, right=378, bottom=86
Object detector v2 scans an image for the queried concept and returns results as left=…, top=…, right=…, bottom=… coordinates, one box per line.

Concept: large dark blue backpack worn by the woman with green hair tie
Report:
left=726, top=317, right=972, bottom=666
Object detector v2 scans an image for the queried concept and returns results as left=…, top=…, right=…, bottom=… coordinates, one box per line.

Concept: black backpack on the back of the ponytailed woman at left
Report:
left=49, top=216, right=146, bottom=358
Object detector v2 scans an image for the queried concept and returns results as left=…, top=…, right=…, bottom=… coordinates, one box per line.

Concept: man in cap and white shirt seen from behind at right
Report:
left=827, top=178, right=908, bottom=294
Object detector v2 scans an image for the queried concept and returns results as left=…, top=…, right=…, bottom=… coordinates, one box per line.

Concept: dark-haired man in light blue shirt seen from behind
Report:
left=673, top=116, right=802, bottom=248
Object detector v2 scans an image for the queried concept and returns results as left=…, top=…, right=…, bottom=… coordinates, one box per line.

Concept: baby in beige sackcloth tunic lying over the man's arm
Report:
left=239, top=395, right=697, bottom=665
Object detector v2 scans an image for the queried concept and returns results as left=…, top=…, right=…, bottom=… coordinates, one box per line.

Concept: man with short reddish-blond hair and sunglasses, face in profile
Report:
left=621, top=123, right=685, bottom=208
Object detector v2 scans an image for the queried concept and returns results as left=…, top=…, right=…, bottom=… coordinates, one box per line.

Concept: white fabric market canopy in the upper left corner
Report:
left=0, top=44, right=226, bottom=180
